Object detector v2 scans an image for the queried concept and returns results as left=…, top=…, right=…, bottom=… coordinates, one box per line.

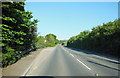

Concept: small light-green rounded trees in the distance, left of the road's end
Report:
left=36, top=34, right=59, bottom=48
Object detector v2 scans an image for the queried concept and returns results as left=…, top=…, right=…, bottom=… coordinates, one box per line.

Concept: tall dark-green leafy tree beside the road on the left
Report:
left=0, top=1, right=38, bottom=67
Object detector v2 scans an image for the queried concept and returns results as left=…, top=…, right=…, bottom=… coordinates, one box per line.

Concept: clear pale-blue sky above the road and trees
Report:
left=25, top=2, right=118, bottom=40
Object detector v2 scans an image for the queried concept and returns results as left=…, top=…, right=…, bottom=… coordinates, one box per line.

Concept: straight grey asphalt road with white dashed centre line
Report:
left=24, top=45, right=119, bottom=76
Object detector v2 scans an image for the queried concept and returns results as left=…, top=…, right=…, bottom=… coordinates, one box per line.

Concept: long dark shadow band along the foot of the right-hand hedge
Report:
left=64, top=46, right=120, bottom=64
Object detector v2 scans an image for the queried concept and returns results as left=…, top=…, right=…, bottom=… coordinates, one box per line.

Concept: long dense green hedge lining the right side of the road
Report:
left=67, top=19, right=120, bottom=56
